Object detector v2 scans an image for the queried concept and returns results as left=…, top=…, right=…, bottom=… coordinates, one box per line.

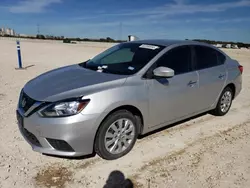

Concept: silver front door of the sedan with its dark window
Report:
left=147, top=46, right=199, bottom=127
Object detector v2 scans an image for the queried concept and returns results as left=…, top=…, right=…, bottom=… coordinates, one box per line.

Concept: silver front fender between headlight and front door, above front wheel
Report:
left=81, top=76, right=148, bottom=129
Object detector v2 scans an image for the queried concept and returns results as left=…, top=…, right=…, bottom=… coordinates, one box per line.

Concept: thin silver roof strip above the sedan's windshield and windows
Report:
left=129, top=39, right=207, bottom=47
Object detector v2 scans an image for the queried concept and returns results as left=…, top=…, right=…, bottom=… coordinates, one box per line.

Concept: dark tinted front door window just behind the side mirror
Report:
left=156, top=46, right=192, bottom=74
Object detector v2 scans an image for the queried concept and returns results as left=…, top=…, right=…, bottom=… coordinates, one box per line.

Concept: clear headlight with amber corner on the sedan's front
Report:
left=40, top=100, right=89, bottom=117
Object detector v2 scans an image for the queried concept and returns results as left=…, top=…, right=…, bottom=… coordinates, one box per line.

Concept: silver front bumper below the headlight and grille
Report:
left=17, top=109, right=104, bottom=157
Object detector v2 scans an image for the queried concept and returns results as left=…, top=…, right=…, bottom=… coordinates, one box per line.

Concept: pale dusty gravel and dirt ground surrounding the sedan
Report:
left=0, top=40, right=250, bottom=188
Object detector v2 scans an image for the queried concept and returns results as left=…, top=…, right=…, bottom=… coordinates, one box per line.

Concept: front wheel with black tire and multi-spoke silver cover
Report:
left=94, top=110, right=139, bottom=160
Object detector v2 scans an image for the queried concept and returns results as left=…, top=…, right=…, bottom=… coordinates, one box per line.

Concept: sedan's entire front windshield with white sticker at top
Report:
left=80, top=43, right=164, bottom=75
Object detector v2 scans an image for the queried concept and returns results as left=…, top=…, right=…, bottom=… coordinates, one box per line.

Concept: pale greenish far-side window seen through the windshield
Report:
left=101, top=48, right=134, bottom=64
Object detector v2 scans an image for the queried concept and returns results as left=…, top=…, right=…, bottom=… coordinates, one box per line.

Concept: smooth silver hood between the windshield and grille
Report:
left=23, top=65, right=127, bottom=102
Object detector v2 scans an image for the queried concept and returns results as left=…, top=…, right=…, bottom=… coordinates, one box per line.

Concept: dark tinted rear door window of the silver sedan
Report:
left=194, top=46, right=219, bottom=70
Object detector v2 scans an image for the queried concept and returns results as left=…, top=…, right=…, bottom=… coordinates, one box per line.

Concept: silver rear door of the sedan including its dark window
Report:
left=193, top=45, right=227, bottom=111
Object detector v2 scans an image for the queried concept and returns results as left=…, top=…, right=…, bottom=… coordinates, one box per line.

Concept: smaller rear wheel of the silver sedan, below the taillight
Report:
left=212, top=87, right=233, bottom=116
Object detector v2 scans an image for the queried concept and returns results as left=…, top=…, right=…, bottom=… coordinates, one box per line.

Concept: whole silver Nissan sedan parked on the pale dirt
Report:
left=17, top=40, right=243, bottom=160
